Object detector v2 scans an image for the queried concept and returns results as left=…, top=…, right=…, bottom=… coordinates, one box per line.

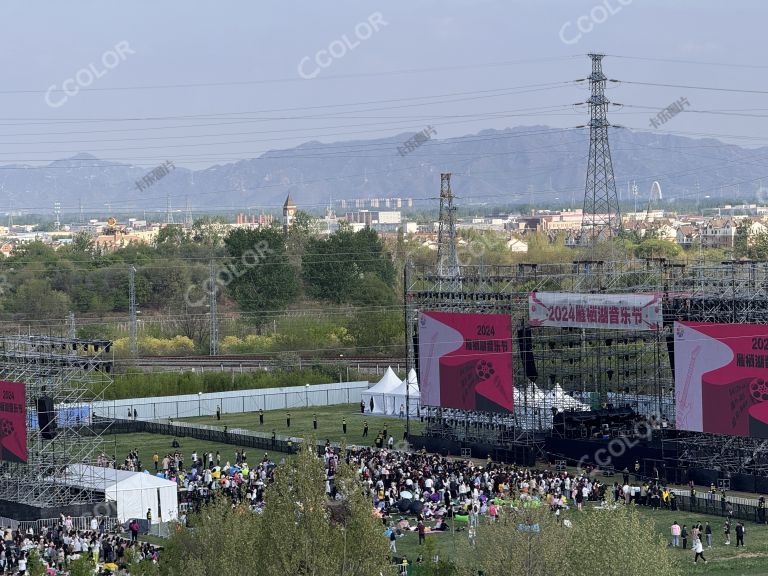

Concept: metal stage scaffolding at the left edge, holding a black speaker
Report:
left=0, top=336, right=113, bottom=508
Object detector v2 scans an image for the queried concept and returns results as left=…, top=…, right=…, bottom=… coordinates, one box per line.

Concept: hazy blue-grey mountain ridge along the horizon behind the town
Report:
left=0, top=126, right=768, bottom=213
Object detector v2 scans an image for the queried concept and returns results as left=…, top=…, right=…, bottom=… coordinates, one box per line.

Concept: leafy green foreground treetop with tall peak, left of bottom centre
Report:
left=160, top=441, right=389, bottom=576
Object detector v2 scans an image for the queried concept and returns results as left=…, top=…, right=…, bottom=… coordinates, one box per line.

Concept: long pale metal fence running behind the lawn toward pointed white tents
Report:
left=93, top=381, right=368, bottom=420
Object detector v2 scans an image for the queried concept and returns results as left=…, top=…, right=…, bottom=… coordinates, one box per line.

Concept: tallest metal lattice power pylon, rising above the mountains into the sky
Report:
left=581, top=54, right=621, bottom=244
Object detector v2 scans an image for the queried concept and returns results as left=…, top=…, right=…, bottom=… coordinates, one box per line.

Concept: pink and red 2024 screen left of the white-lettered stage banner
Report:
left=419, top=312, right=513, bottom=412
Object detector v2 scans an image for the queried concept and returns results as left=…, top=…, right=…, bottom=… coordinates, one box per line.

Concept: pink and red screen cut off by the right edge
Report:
left=674, top=322, right=768, bottom=438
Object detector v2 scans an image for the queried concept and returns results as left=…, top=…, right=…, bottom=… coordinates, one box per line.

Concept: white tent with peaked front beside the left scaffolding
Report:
left=64, top=464, right=179, bottom=522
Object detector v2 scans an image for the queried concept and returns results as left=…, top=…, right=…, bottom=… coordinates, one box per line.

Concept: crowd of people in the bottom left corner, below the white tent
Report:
left=0, top=516, right=159, bottom=576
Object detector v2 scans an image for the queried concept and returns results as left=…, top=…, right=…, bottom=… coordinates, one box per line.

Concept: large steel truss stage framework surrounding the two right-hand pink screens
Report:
left=405, top=259, right=768, bottom=474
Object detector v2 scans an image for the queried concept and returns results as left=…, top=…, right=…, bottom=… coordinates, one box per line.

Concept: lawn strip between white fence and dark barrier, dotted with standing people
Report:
left=179, top=404, right=423, bottom=446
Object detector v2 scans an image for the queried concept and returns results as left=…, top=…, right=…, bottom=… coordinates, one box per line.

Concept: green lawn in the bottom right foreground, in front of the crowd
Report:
left=390, top=507, right=768, bottom=576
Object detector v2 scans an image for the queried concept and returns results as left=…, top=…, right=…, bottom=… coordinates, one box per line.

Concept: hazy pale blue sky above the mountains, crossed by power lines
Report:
left=0, top=0, right=768, bottom=168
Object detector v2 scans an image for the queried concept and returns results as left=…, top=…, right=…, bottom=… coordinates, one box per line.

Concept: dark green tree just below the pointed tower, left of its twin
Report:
left=224, top=228, right=299, bottom=323
